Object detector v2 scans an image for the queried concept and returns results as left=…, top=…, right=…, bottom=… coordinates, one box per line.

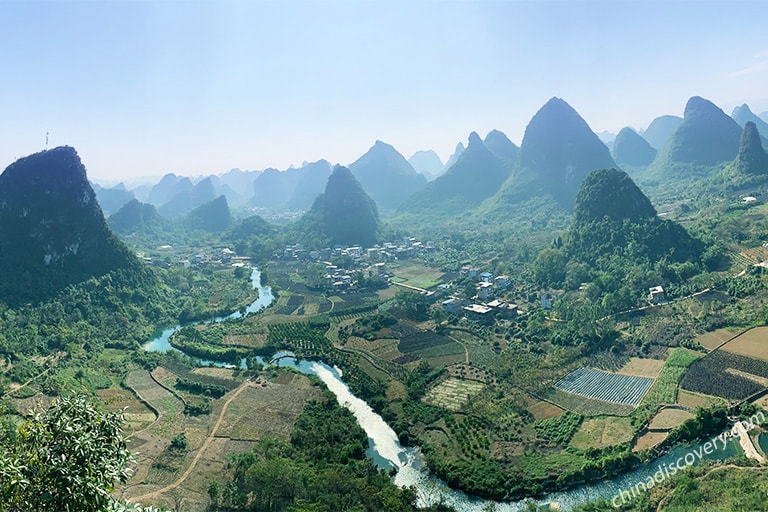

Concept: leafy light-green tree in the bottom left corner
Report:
left=0, top=397, right=131, bottom=512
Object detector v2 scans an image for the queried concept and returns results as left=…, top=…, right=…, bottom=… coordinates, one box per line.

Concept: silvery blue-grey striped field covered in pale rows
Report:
left=555, top=368, right=653, bottom=405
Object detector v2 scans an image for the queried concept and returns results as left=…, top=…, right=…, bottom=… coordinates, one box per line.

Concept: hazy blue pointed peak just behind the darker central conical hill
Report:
left=349, top=140, right=427, bottom=210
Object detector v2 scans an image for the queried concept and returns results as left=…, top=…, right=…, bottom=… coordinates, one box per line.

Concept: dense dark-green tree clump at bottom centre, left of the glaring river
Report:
left=212, top=393, right=444, bottom=512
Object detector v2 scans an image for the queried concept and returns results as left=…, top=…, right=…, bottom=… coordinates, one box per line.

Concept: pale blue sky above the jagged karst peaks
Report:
left=0, top=0, right=768, bottom=179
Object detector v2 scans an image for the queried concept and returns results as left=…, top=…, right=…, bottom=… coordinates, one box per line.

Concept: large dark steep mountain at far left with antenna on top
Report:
left=0, top=146, right=140, bottom=304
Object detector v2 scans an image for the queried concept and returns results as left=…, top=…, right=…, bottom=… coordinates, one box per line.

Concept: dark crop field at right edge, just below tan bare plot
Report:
left=680, top=350, right=768, bottom=400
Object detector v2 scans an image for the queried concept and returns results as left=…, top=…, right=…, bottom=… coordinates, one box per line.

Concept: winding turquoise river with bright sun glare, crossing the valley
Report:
left=144, top=269, right=744, bottom=512
